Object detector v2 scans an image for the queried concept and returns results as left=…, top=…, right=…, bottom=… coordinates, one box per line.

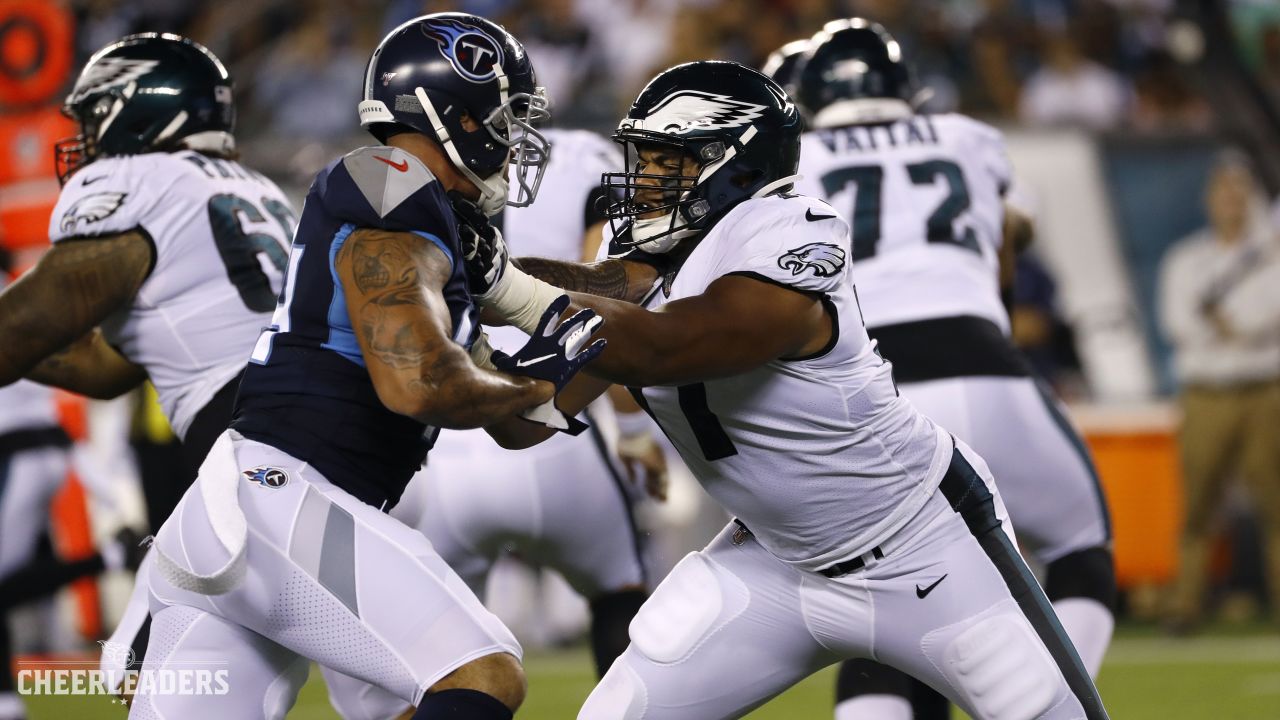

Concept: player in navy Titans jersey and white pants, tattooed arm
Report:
left=133, top=13, right=603, bottom=720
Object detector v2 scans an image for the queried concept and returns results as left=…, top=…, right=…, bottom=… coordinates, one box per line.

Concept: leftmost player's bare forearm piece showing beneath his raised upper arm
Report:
left=27, top=329, right=147, bottom=400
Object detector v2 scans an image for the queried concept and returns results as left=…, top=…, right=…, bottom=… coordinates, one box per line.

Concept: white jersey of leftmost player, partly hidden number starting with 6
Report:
left=49, top=151, right=297, bottom=437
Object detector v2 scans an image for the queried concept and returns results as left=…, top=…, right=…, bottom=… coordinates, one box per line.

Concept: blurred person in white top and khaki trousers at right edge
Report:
left=1160, top=152, right=1280, bottom=632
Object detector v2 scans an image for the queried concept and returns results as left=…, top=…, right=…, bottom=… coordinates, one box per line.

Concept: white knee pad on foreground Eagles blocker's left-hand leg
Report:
left=631, top=553, right=750, bottom=664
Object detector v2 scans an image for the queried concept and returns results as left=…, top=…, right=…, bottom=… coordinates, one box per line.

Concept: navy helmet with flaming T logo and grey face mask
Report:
left=358, top=13, right=550, bottom=215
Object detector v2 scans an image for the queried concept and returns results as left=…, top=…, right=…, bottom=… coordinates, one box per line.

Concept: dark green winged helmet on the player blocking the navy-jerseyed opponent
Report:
left=602, top=60, right=801, bottom=252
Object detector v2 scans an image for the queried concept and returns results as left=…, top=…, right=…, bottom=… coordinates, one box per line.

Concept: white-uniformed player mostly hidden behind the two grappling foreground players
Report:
left=325, top=129, right=662, bottom=719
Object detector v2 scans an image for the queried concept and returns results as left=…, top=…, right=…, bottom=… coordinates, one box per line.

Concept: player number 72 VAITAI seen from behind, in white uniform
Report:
left=794, top=19, right=1116, bottom=720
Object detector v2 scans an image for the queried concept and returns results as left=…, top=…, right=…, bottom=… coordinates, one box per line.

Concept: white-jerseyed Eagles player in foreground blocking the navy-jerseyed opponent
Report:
left=471, top=61, right=1106, bottom=720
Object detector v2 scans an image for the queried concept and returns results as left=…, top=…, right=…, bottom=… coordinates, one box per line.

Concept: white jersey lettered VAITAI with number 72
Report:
left=796, top=114, right=1011, bottom=333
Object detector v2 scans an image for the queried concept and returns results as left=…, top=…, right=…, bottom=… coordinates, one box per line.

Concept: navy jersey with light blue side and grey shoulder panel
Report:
left=232, top=147, right=479, bottom=507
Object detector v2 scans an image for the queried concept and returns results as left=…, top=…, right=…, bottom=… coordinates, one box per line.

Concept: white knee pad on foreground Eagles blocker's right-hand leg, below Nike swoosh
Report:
left=924, top=611, right=1065, bottom=720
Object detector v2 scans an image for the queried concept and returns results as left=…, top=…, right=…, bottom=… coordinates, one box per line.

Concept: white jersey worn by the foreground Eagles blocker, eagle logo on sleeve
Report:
left=629, top=195, right=951, bottom=569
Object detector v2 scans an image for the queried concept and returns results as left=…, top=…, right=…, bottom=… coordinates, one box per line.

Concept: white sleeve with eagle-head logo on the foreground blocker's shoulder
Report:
left=704, top=196, right=851, bottom=295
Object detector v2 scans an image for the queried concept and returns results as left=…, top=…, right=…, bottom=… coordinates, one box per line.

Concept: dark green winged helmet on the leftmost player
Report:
left=54, top=32, right=236, bottom=183
